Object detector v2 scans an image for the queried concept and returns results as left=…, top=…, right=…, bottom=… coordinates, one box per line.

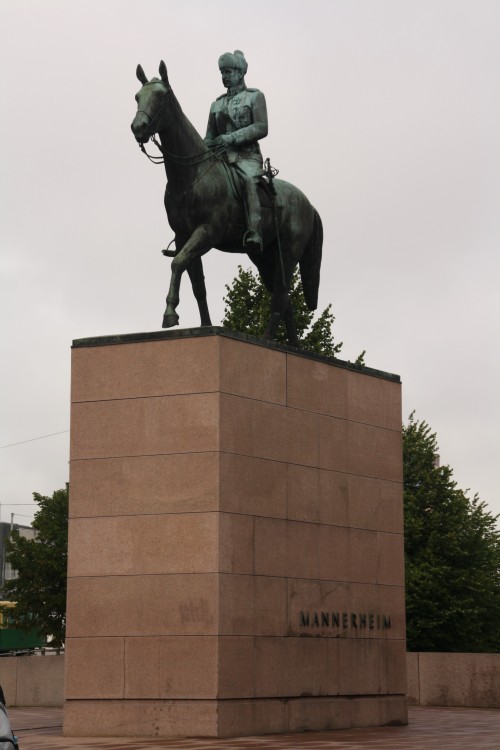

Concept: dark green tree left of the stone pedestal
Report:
left=4, top=485, right=69, bottom=647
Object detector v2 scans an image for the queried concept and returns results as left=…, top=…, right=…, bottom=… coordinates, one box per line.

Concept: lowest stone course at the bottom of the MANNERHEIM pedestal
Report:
left=64, top=695, right=408, bottom=737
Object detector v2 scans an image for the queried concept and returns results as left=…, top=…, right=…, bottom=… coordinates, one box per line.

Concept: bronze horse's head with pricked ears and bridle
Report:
left=131, top=60, right=170, bottom=143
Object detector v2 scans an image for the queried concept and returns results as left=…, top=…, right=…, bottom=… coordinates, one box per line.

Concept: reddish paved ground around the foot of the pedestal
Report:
left=9, top=708, right=500, bottom=750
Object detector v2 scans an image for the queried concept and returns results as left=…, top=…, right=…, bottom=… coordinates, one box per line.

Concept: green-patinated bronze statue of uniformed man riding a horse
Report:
left=132, top=50, right=323, bottom=346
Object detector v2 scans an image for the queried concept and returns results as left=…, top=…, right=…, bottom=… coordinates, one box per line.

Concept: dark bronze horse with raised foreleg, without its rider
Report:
left=132, top=60, right=323, bottom=345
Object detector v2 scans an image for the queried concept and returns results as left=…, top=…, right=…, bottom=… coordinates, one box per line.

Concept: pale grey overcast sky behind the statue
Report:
left=0, top=0, right=500, bottom=523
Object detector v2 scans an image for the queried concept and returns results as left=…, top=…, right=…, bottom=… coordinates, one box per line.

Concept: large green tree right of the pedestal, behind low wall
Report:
left=403, top=414, right=500, bottom=652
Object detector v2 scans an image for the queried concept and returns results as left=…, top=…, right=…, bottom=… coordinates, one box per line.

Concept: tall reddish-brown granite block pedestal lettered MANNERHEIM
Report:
left=64, top=328, right=407, bottom=737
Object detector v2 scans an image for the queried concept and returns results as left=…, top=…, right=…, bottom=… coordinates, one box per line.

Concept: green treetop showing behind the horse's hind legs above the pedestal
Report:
left=222, top=266, right=342, bottom=357
